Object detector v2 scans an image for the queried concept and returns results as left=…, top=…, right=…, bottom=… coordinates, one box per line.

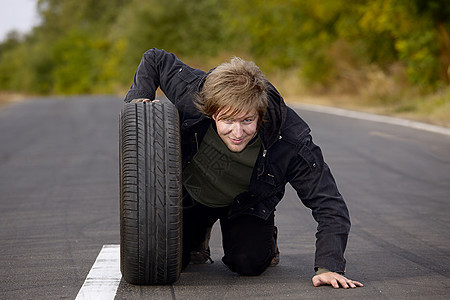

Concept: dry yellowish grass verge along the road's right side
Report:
left=270, top=68, right=450, bottom=127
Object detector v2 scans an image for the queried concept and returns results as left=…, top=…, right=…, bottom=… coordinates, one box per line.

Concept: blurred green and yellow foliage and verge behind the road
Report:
left=0, top=0, right=450, bottom=125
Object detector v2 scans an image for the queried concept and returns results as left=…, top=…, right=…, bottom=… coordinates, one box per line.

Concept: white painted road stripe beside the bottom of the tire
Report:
left=75, top=245, right=122, bottom=300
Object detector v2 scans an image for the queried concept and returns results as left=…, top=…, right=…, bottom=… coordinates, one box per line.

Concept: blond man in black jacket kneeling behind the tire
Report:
left=125, top=49, right=363, bottom=288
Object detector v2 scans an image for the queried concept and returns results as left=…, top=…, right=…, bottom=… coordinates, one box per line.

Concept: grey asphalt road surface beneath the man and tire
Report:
left=0, top=97, right=450, bottom=299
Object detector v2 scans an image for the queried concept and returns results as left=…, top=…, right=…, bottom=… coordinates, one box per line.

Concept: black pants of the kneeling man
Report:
left=183, top=195, right=276, bottom=276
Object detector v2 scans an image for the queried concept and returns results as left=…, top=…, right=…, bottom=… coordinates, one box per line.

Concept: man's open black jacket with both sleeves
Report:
left=125, top=49, right=350, bottom=273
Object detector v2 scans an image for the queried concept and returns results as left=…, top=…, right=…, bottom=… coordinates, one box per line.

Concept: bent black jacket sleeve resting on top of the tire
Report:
left=124, top=48, right=200, bottom=103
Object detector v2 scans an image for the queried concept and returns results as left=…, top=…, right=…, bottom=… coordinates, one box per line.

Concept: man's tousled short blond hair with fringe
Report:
left=196, top=57, right=267, bottom=126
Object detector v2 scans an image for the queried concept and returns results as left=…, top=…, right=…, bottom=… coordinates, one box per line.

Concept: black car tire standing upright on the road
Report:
left=119, top=101, right=182, bottom=285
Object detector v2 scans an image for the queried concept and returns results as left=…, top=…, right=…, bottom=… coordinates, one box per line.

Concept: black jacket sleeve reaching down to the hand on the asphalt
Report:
left=288, top=135, right=350, bottom=273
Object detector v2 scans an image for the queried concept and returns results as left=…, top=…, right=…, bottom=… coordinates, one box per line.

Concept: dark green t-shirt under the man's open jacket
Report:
left=183, top=125, right=261, bottom=207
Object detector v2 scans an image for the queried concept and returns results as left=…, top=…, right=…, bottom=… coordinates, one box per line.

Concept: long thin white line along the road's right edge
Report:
left=290, top=103, right=450, bottom=136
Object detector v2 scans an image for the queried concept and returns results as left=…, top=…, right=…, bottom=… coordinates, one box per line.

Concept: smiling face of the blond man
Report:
left=212, top=109, right=258, bottom=152
